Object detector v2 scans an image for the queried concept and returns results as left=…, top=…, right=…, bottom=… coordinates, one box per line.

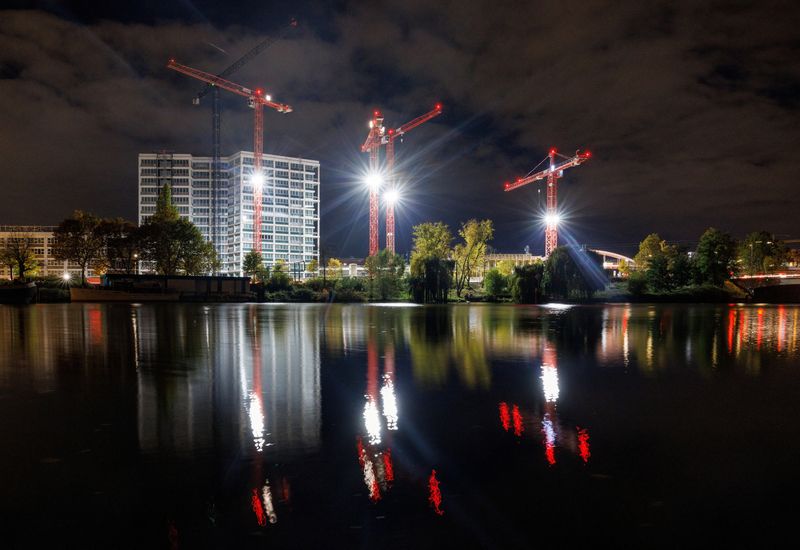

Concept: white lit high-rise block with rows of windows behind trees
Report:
left=139, top=151, right=320, bottom=276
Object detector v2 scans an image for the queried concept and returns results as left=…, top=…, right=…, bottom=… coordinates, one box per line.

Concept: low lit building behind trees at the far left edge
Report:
left=0, top=225, right=88, bottom=279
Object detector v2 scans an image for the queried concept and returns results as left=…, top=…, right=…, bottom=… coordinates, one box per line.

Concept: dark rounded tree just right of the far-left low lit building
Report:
left=53, top=210, right=106, bottom=284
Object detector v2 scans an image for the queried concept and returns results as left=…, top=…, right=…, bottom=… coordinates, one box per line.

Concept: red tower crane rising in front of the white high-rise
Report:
left=167, top=59, right=292, bottom=253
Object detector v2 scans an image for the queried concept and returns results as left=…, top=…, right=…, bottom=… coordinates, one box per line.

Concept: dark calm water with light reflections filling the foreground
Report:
left=0, top=304, right=800, bottom=549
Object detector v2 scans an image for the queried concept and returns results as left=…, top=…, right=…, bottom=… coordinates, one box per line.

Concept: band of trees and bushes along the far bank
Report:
left=0, top=185, right=800, bottom=304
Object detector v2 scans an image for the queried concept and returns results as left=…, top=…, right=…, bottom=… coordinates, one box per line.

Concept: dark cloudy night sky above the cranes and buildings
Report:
left=0, top=0, right=800, bottom=256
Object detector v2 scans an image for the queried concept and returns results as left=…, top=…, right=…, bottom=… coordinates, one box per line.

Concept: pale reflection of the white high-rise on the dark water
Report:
left=138, top=306, right=321, bottom=453
